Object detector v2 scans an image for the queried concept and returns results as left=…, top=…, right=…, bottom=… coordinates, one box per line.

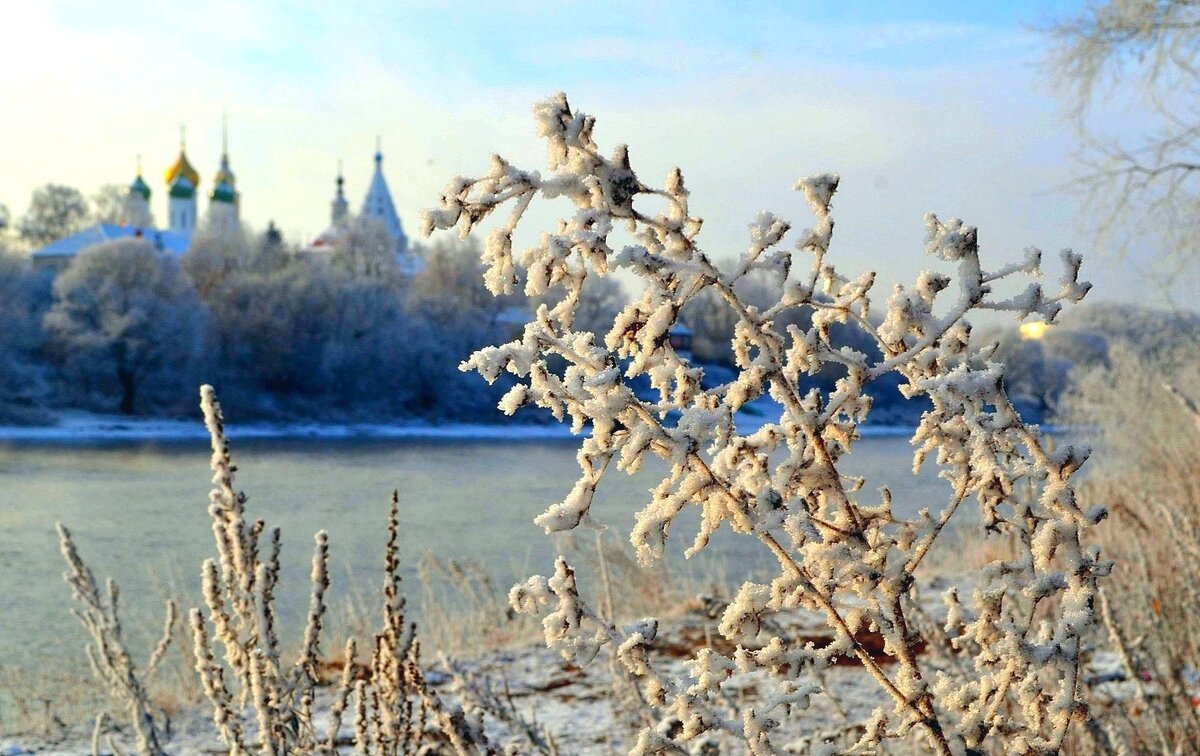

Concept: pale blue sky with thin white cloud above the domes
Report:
left=0, top=0, right=1156, bottom=304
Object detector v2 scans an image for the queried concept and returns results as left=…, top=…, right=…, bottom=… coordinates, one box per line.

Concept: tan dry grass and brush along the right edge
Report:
left=1070, top=346, right=1200, bottom=754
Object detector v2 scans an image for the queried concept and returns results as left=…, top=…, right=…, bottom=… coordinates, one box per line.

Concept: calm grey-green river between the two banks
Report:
left=0, top=437, right=947, bottom=668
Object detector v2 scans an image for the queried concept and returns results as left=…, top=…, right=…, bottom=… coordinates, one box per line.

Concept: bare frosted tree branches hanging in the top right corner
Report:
left=1045, top=0, right=1200, bottom=277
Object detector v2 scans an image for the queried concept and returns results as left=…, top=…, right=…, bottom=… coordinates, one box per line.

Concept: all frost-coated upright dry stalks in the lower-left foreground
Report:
left=59, top=386, right=554, bottom=756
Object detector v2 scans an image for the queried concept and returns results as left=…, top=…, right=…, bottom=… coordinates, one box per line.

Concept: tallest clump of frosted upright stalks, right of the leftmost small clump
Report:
left=191, top=386, right=491, bottom=756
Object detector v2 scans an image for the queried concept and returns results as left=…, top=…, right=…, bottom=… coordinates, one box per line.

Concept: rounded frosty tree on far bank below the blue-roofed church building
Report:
left=44, top=239, right=202, bottom=413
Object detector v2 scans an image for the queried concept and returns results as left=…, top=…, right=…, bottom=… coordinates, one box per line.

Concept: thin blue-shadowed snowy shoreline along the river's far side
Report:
left=0, top=413, right=914, bottom=444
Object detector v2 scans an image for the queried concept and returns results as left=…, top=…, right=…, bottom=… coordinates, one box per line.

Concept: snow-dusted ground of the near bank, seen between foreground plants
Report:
left=0, top=590, right=1161, bottom=756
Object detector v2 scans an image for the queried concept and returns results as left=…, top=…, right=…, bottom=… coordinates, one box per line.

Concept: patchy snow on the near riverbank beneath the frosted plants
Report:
left=0, top=576, right=1161, bottom=756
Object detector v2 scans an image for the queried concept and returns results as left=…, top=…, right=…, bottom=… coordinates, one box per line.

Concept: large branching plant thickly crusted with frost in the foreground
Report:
left=422, top=95, right=1111, bottom=754
